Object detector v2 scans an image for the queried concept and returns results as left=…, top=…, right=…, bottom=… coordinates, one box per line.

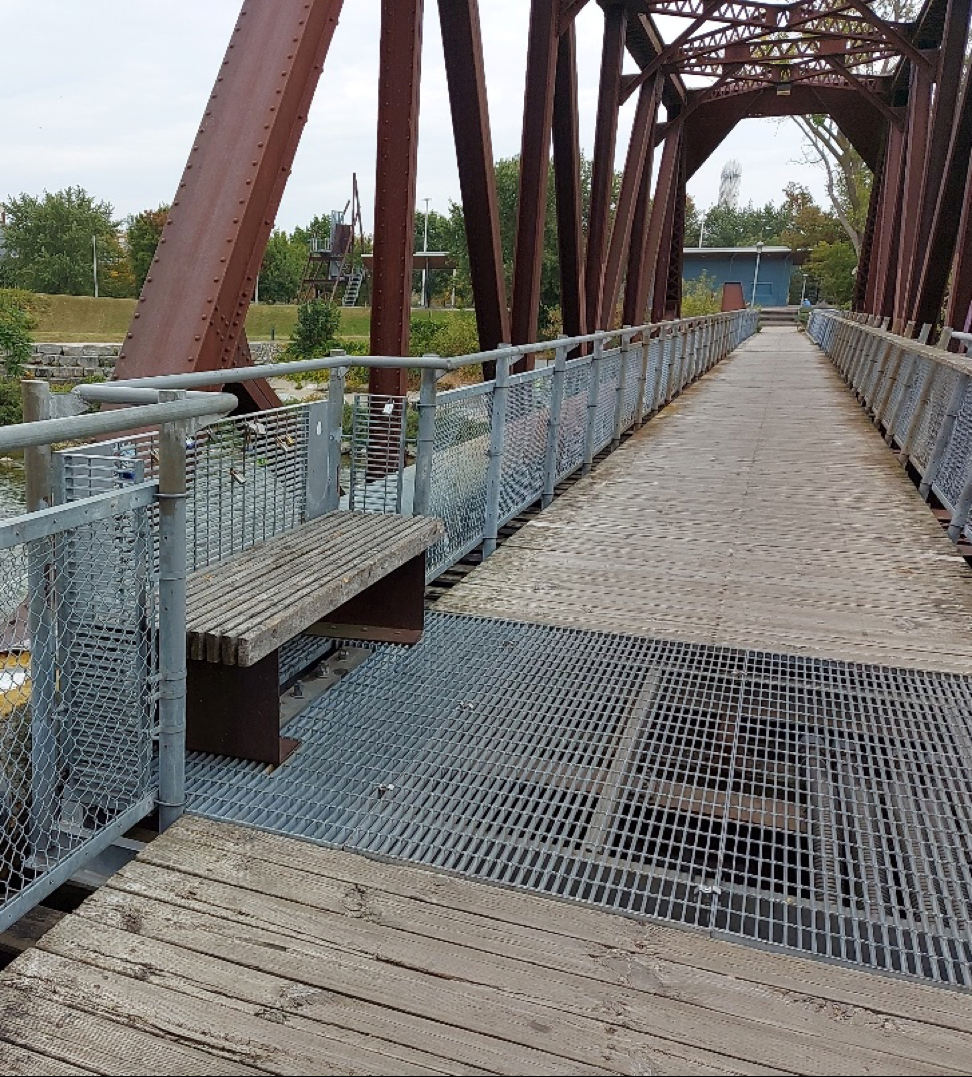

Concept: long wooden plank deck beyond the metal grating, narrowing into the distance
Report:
left=437, top=327, right=972, bottom=673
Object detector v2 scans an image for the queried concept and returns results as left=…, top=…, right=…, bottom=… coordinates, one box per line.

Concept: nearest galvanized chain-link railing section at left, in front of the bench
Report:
left=0, top=382, right=236, bottom=931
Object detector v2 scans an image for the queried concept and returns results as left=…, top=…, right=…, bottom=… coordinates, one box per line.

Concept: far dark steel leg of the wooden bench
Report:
left=307, top=554, right=425, bottom=643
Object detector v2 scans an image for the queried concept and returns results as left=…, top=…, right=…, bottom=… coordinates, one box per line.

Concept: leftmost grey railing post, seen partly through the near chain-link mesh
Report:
left=20, top=379, right=58, bottom=857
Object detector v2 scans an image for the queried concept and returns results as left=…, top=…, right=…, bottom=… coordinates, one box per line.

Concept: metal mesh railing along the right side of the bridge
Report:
left=807, top=310, right=972, bottom=542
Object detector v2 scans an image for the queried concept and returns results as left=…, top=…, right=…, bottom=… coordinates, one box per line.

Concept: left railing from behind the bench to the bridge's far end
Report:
left=55, top=310, right=758, bottom=579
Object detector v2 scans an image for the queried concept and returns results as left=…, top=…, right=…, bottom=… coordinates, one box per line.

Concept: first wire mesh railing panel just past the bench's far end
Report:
left=427, top=384, right=493, bottom=578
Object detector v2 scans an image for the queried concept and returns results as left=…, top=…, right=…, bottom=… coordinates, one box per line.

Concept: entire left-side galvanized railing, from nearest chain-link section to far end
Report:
left=0, top=311, right=757, bottom=929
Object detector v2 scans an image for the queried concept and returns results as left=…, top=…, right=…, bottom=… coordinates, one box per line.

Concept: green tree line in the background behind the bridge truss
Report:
left=0, top=164, right=857, bottom=314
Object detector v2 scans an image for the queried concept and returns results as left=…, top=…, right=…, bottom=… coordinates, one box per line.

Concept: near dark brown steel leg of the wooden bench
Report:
left=186, top=651, right=298, bottom=767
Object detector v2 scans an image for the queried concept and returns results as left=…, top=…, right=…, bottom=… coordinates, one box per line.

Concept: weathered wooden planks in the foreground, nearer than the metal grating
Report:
left=0, top=817, right=972, bottom=1075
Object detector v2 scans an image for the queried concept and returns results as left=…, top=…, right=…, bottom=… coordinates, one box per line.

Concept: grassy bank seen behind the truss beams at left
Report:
left=32, top=295, right=471, bottom=344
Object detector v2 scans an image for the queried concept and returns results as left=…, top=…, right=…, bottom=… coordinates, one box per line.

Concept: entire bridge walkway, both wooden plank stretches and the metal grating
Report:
left=0, top=330, right=972, bottom=1074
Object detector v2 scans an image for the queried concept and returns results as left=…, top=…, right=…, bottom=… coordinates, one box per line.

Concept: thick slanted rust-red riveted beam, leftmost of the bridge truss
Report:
left=115, top=0, right=341, bottom=406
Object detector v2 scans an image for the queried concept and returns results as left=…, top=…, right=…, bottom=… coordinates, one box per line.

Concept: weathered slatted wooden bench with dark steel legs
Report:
left=186, top=512, right=443, bottom=766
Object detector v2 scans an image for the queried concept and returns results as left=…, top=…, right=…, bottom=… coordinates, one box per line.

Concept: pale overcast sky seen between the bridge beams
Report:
left=0, top=0, right=823, bottom=232
